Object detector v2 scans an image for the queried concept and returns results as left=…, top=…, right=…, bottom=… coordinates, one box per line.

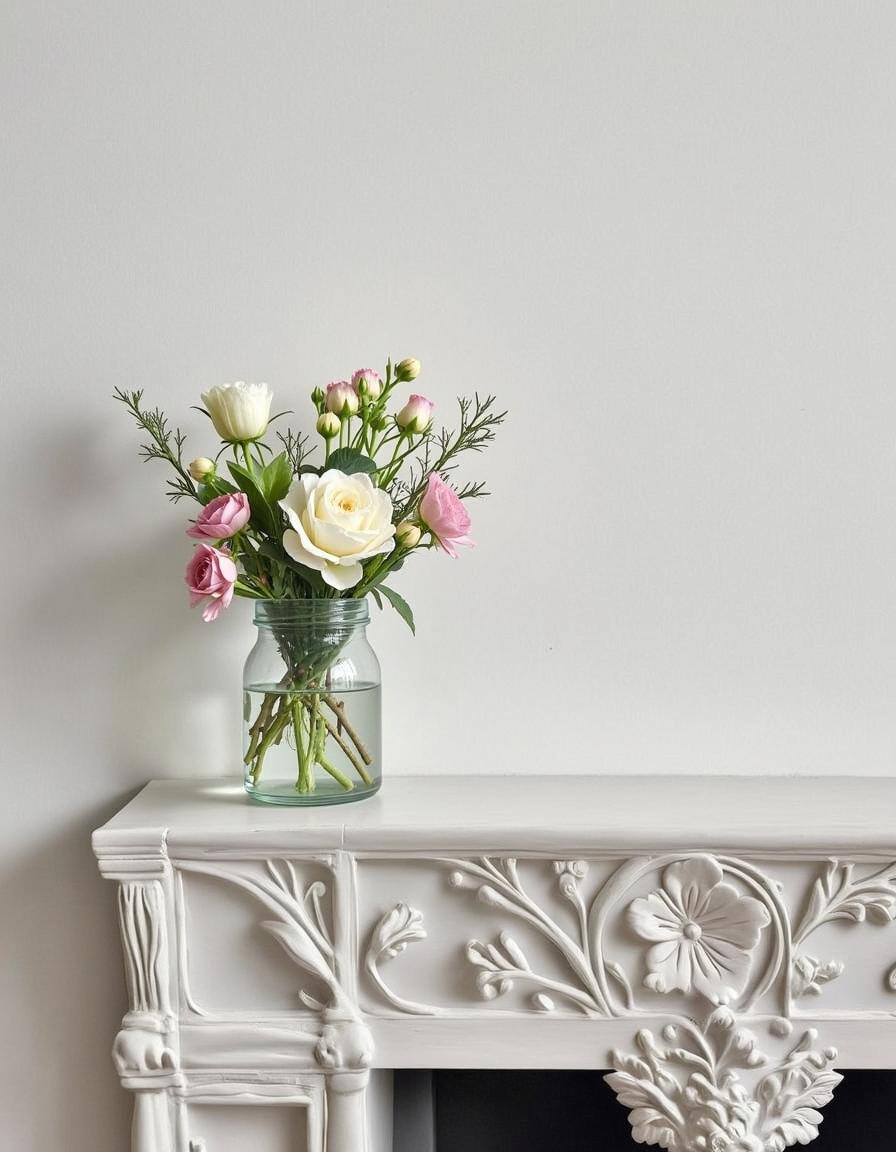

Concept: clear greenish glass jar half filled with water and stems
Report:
left=243, top=599, right=382, bottom=804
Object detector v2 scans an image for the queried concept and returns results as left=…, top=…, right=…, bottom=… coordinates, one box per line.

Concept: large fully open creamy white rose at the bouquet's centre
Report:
left=280, top=468, right=395, bottom=591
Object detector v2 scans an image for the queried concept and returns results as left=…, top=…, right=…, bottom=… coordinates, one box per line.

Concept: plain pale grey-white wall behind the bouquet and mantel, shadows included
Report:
left=0, top=0, right=896, bottom=1152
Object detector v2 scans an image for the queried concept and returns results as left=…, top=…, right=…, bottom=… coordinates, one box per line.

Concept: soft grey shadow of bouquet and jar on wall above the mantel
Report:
left=6, top=419, right=252, bottom=785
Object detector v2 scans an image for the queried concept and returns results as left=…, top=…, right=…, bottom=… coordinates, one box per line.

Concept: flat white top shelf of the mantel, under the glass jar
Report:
left=94, top=775, right=896, bottom=852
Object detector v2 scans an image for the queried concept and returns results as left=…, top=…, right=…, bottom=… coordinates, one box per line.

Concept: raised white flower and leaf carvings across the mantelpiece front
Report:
left=123, top=852, right=896, bottom=1152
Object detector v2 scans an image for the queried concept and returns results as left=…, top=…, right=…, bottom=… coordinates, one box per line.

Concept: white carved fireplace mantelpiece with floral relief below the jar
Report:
left=93, top=775, right=896, bottom=1152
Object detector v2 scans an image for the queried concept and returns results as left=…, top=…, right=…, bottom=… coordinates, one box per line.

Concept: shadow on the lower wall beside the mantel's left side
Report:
left=0, top=789, right=136, bottom=1152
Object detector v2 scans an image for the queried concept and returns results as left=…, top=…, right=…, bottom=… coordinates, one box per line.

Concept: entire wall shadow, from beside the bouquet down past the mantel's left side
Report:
left=0, top=417, right=244, bottom=1152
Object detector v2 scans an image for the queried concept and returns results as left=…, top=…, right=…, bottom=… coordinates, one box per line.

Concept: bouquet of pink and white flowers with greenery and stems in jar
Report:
left=115, top=358, right=506, bottom=791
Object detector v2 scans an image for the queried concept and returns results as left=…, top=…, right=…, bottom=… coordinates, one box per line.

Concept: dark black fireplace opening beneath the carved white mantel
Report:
left=394, top=1069, right=896, bottom=1152
